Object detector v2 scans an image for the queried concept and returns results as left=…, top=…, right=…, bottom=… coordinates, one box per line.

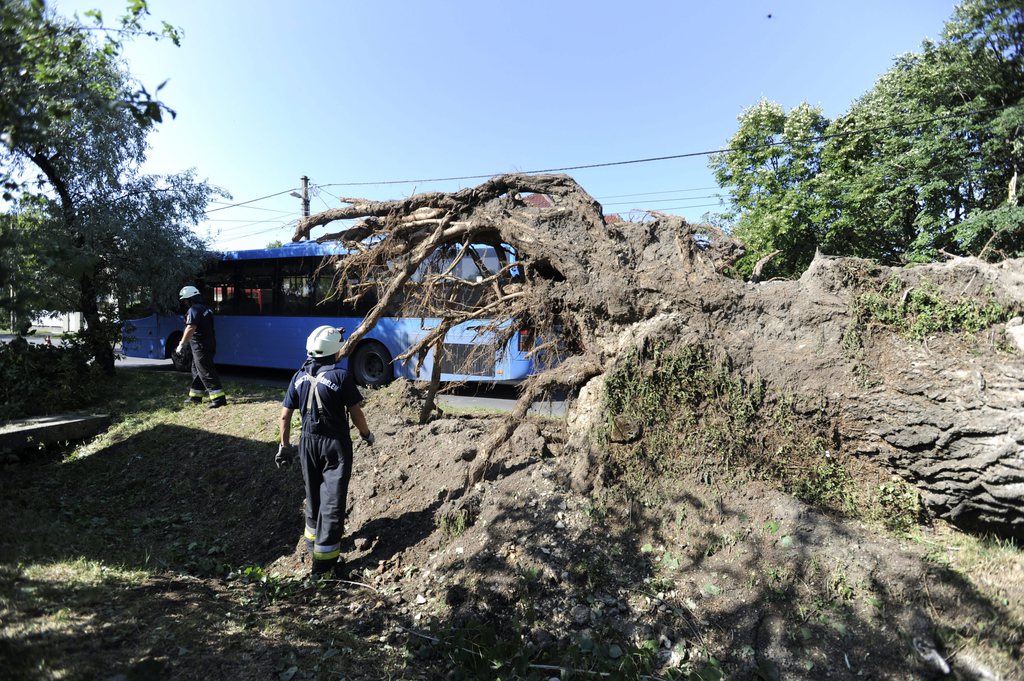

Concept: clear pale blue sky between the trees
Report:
left=52, top=0, right=954, bottom=249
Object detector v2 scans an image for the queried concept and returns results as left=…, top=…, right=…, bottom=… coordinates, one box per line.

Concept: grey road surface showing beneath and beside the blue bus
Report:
left=0, top=334, right=565, bottom=418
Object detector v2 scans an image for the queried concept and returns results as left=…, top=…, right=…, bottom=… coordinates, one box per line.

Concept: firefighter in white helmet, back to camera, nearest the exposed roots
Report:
left=274, top=327, right=374, bottom=578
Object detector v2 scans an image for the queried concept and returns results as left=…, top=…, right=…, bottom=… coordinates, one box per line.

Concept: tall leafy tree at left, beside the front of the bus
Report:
left=0, top=0, right=219, bottom=371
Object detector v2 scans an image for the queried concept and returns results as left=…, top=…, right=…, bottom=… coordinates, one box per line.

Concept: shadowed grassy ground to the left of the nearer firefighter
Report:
left=0, top=425, right=430, bottom=679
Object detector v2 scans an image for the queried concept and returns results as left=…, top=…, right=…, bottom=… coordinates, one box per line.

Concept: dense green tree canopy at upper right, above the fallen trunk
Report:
left=711, top=0, right=1024, bottom=275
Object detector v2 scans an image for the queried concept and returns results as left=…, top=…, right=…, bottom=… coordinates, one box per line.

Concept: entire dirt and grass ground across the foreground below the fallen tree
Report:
left=0, top=368, right=1024, bottom=681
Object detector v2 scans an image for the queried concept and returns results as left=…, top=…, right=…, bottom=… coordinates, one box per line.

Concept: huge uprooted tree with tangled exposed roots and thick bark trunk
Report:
left=293, top=175, right=1024, bottom=537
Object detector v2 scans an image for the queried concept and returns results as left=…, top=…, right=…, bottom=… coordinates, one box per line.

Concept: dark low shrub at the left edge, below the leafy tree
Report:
left=0, top=337, right=98, bottom=419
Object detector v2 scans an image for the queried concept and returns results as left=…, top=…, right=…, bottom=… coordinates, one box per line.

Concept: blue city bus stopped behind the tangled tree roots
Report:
left=122, top=242, right=535, bottom=387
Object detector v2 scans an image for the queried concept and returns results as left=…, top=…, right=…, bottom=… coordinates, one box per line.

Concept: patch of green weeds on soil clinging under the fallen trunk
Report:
left=604, top=345, right=888, bottom=517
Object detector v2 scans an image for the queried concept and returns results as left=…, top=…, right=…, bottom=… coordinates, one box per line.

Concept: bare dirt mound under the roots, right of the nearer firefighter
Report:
left=253, top=387, right=1024, bottom=679
